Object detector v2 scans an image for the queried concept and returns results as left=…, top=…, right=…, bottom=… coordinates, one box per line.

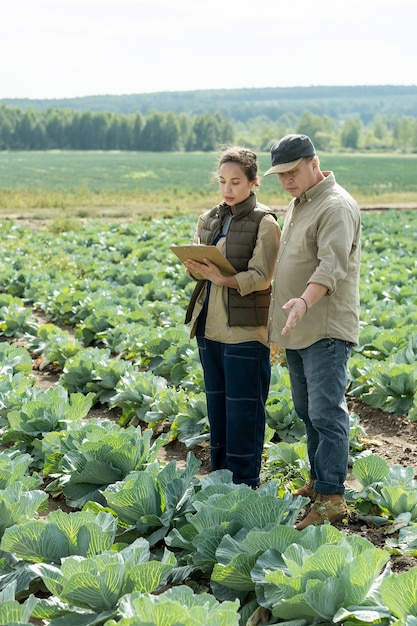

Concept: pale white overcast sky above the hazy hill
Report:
left=0, top=0, right=417, bottom=99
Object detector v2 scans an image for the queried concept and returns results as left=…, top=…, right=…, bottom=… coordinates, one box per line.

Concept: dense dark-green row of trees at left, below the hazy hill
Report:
left=0, top=105, right=233, bottom=152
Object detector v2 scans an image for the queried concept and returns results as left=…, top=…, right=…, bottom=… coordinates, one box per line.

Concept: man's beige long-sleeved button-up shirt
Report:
left=268, top=172, right=361, bottom=350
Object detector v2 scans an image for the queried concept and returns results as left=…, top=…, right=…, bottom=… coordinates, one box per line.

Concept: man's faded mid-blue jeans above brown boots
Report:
left=286, top=339, right=352, bottom=494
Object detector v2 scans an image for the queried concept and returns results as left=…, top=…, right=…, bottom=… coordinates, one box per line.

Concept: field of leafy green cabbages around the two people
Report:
left=0, top=210, right=417, bottom=626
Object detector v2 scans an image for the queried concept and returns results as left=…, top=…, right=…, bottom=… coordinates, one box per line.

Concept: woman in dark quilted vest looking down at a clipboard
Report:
left=185, top=146, right=280, bottom=488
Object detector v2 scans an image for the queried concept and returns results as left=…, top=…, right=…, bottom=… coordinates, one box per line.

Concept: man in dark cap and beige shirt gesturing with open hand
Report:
left=264, top=135, right=361, bottom=530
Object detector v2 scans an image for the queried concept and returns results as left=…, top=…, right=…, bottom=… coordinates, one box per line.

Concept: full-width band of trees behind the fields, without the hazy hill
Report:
left=0, top=105, right=417, bottom=153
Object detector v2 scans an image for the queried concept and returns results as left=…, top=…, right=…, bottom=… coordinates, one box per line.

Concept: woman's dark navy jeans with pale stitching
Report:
left=197, top=337, right=271, bottom=487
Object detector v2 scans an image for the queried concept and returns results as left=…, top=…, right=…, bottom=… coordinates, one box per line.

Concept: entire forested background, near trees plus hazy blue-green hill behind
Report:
left=0, top=86, right=417, bottom=154
